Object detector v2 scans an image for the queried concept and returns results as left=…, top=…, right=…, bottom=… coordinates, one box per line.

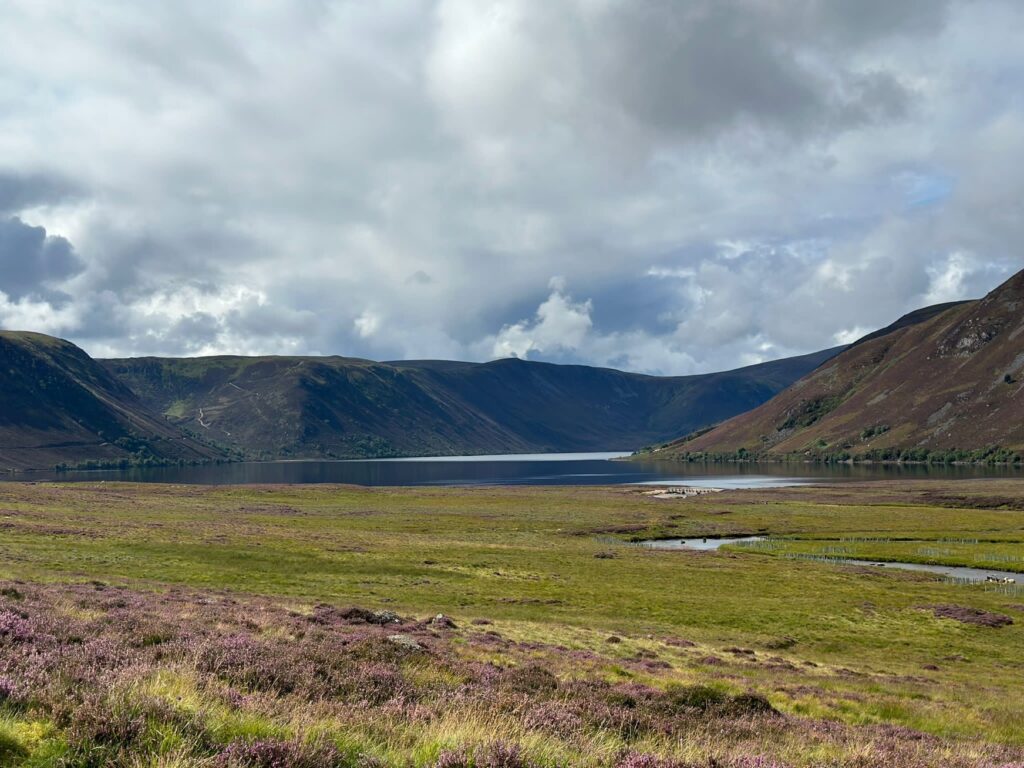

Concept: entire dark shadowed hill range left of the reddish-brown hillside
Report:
left=0, top=332, right=839, bottom=471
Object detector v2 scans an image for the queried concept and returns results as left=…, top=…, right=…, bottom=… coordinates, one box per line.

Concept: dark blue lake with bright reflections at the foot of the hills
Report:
left=8, top=453, right=1024, bottom=488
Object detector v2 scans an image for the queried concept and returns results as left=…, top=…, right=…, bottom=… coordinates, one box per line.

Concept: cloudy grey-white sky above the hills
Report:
left=0, top=0, right=1024, bottom=375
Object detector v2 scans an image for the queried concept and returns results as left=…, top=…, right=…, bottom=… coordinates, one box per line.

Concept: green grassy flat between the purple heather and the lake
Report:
left=0, top=480, right=1024, bottom=765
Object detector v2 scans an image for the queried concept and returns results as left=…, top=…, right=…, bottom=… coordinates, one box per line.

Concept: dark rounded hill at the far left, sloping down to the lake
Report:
left=0, top=331, right=218, bottom=470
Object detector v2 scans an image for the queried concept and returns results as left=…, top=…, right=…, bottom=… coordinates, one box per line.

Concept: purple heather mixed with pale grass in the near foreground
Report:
left=0, top=584, right=1018, bottom=768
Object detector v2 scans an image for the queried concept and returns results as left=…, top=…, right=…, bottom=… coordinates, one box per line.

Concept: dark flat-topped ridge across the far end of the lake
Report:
left=102, top=350, right=839, bottom=458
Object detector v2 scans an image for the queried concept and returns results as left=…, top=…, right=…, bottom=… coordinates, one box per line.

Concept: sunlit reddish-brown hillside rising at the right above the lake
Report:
left=660, top=271, right=1024, bottom=461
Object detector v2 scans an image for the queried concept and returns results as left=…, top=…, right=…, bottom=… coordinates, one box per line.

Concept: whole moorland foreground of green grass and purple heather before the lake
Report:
left=0, top=480, right=1024, bottom=768
